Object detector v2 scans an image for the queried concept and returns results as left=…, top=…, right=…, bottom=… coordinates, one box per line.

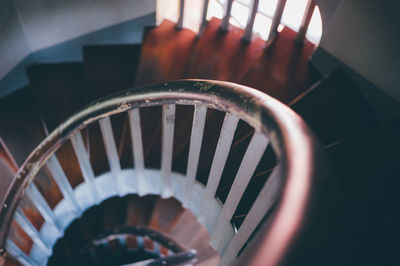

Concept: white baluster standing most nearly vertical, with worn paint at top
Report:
left=161, top=104, right=175, bottom=198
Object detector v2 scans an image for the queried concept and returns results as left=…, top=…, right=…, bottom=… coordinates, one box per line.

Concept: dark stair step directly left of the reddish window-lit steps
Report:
left=83, top=44, right=141, bottom=102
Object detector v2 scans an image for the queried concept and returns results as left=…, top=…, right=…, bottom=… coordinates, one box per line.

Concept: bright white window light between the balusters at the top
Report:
left=157, top=0, right=322, bottom=44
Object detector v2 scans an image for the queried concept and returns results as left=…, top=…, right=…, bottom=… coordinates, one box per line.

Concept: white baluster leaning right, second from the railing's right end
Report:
left=210, top=132, right=269, bottom=252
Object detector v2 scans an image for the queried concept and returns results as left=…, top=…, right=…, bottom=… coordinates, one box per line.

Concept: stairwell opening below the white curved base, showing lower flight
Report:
left=47, top=194, right=219, bottom=266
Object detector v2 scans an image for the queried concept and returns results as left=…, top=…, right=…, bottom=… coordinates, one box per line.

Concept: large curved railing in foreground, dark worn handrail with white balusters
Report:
left=0, top=80, right=323, bottom=265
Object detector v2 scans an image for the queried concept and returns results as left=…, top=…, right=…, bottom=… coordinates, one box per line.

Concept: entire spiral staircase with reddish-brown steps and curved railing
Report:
left=0, top=1, right=398, bottom=265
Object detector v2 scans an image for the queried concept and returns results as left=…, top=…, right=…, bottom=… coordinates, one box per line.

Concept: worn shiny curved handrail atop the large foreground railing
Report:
left=0, top=80, right=320, bottom=265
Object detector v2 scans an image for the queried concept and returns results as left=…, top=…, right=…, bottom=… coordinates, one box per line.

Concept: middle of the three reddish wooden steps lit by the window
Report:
left=185, top=18, right=266, bottom=82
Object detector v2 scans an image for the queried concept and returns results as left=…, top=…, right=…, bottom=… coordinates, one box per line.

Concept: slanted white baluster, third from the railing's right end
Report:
left=199, top=114, right=239, bottom=228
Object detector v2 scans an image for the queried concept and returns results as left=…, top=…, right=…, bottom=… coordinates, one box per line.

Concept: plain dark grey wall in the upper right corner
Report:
left=315, top=0, right=400, bottom=102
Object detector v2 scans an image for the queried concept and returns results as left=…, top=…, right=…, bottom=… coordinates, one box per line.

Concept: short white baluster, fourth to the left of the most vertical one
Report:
left=47, top=155, right=82, bottom=216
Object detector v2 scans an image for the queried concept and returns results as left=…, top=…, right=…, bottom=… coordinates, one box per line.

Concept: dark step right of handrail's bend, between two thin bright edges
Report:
left=290, top=69, right=378, bottom=145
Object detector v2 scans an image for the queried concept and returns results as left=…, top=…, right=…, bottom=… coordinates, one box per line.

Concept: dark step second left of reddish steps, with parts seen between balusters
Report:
left=27, top=62, right=84, bottom=207
